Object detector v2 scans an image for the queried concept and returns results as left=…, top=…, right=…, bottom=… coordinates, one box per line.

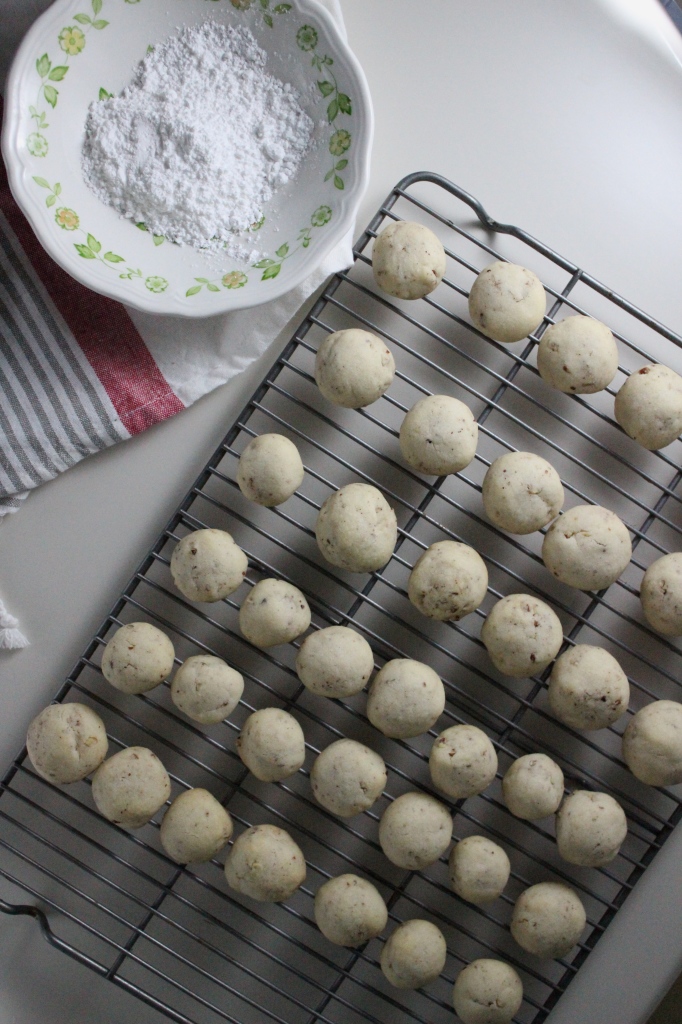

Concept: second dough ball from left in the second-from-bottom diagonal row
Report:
left=171, top=654, right=244, bottom=725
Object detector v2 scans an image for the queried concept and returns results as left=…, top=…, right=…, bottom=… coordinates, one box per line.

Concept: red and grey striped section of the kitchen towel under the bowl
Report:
left=0, top=152, right=184, bottom=514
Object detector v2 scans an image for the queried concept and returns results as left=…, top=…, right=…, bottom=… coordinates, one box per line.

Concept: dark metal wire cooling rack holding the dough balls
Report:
left=0, top=174, right=682, bottom=1024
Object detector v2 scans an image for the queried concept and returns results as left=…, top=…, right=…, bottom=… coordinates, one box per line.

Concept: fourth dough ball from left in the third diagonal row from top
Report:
left=480, top=594, right=563, bottom=679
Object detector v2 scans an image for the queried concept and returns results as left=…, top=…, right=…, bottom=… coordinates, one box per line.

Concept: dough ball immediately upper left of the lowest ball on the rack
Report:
left=381, top=919, right=447, bottom=988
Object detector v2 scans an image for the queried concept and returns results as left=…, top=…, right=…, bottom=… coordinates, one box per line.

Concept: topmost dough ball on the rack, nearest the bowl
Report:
left=372, top=220, right=446, bottom=299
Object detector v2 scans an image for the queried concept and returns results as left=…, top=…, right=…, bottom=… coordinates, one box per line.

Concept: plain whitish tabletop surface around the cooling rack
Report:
left=0, top=0, right=682, bottom=1024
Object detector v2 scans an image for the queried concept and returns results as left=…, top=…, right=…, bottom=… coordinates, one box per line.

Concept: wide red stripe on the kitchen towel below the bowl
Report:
left=0, top=122, right=184, bottom=434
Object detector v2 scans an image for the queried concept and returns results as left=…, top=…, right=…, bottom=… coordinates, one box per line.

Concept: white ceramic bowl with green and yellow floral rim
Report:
left=2, top=0, right=373, bottom=316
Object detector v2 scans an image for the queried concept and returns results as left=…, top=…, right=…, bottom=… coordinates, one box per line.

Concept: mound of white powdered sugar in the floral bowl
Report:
left=82, top=22, right=313, bottom=259
